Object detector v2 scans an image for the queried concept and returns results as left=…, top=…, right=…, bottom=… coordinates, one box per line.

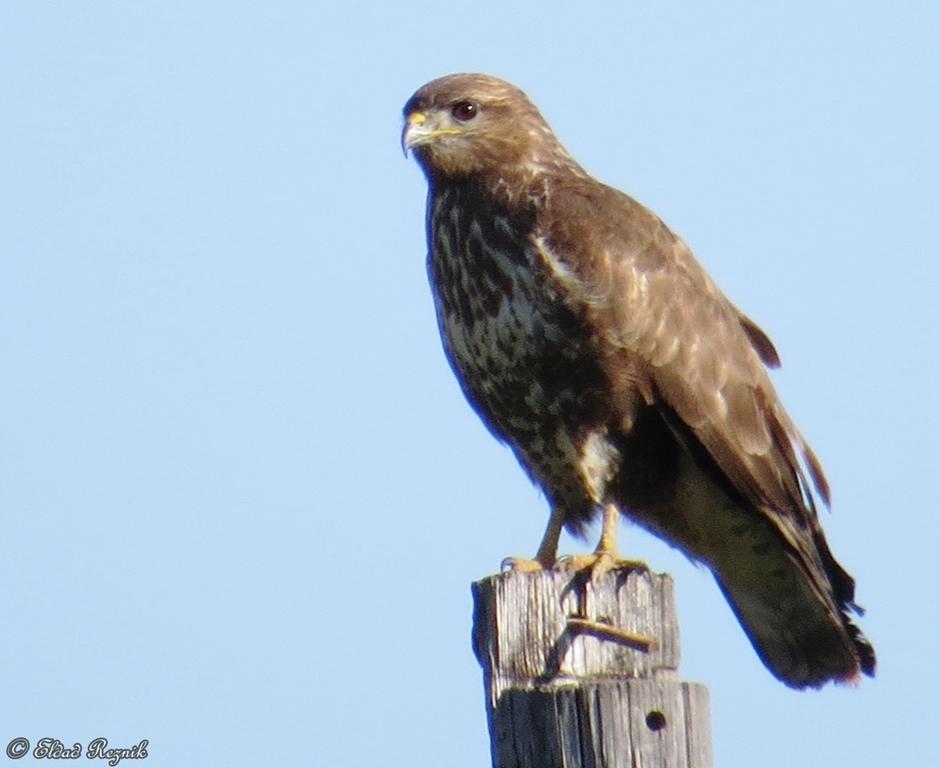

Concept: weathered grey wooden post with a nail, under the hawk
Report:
left=473, top=568, right=712, bottom=768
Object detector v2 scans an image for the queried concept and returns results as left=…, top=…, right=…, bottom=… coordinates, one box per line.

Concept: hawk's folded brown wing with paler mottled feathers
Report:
left=543, top=179, right=829, bottom=536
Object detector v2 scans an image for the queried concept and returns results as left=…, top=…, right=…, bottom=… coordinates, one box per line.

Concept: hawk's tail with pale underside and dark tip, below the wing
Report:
left=620, top=432, right=875, bottom=688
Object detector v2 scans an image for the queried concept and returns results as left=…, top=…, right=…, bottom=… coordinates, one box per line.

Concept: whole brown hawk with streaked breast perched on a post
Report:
left=402, top=74, right=875, bottom=688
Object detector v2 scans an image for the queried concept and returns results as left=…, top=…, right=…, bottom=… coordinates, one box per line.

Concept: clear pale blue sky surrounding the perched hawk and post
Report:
left=0, top=0, right=940, bottom=768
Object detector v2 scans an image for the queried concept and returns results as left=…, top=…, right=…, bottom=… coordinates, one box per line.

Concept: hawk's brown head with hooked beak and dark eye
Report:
left=401, top=74, right=570, bottom=183
